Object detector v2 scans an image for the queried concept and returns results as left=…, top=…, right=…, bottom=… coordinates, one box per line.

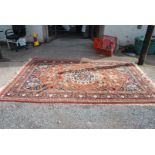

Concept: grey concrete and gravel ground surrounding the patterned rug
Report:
left=0, top=38, right=155, bottom=128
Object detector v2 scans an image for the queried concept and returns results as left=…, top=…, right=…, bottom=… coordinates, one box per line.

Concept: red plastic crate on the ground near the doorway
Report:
left=94, top=35, right=117, bottom=56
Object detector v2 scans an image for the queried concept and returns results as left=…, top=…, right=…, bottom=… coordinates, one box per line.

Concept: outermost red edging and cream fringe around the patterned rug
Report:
left=0, top=57, right=155, bottom=105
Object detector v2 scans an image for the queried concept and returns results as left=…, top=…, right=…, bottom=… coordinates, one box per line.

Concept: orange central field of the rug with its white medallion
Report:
left=25, top=63, right=129, bottom=91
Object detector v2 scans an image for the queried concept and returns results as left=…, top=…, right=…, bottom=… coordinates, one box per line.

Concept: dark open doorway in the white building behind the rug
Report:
left=45, top=25, right=104, bottom=41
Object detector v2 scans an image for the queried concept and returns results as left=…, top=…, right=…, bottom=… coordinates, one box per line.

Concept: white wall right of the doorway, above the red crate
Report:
left=104, top=25, right=155, bottom=45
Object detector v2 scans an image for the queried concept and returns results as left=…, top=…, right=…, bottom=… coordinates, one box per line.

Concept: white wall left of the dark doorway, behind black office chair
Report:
left=0, top=25, right=44, bottom=42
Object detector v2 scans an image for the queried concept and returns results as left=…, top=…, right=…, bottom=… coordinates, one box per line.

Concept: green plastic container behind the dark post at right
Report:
left=135, top=36, right=155, bottom=54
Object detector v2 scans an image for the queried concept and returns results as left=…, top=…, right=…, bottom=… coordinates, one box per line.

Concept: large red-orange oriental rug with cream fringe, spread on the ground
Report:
left=0, top=58, right=155, bottom=104
